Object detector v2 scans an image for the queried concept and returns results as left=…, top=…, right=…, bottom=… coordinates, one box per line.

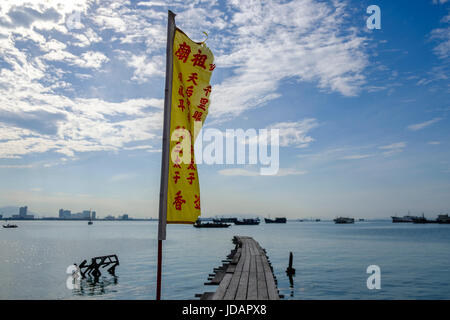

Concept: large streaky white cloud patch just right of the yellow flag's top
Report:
left=211, top=0, right=367, bottom=118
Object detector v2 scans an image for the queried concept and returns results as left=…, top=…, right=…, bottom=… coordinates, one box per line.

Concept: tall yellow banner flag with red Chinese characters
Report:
left=167, top=28, right=215, bottom=223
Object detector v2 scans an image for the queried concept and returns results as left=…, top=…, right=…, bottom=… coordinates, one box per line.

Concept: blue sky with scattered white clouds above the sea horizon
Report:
left=0, top=0, right=450, bottom=218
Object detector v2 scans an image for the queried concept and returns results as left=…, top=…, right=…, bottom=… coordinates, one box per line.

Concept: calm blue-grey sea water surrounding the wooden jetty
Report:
left=0, top=221, right=450, bottom=299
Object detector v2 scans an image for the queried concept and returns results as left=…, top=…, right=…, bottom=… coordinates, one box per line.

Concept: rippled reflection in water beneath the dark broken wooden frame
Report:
left=73, top=275, right=119, bottom=296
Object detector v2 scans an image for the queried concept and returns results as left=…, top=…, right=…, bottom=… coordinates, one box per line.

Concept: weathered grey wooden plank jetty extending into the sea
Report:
left=196, top=236, right=282, bottom=300
